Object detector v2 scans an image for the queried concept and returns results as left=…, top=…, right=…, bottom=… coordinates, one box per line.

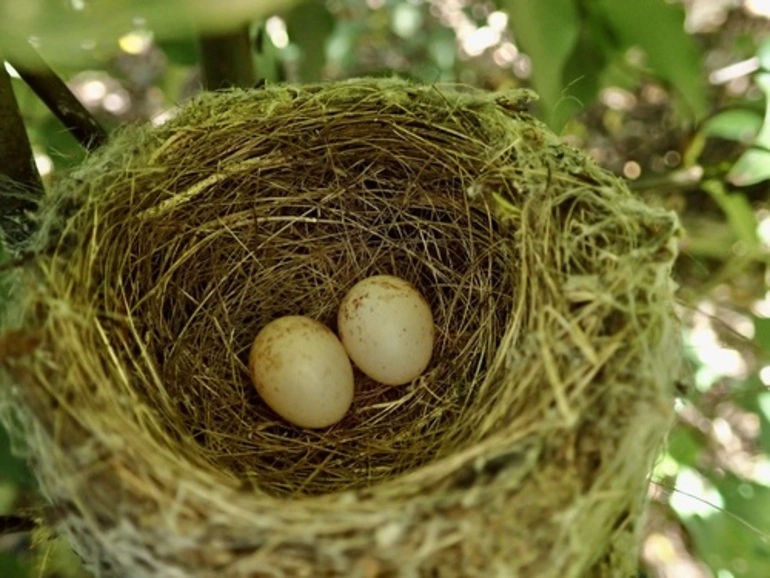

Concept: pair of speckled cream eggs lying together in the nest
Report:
left=249, top=275, right=434, bottom=428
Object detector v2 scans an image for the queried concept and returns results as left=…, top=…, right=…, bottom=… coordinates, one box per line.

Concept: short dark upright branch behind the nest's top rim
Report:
left=199, top=26, right=257, bottom=90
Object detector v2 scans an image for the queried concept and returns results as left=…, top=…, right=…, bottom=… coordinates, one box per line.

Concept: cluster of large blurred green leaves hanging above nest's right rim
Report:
left=503, top=0, right=708, bottom=129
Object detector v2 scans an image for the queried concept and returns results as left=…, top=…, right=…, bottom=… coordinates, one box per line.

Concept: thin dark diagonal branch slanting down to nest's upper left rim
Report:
left=5, top=37, right=107, bottom=150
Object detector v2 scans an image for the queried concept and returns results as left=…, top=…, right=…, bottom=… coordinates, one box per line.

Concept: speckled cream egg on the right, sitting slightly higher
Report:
left=337, top=275, right=435, bottom=385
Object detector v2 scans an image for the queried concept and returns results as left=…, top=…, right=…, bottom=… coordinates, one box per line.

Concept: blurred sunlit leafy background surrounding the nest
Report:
left=0, top=0, right=770, bottom=578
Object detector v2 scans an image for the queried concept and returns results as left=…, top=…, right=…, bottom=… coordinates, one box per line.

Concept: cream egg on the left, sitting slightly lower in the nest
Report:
left=249, top=315, right=354, bottom=428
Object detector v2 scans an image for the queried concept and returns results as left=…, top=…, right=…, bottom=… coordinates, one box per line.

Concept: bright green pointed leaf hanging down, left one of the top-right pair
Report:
left=501, top=0, right=580, bottom=130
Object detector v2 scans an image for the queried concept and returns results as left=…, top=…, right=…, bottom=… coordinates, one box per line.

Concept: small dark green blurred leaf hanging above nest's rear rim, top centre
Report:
left=286, top=0, right=335, bottom=82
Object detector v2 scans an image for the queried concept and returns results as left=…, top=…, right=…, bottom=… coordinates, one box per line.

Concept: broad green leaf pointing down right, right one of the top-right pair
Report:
left=592, top=0, right=708, bottom=118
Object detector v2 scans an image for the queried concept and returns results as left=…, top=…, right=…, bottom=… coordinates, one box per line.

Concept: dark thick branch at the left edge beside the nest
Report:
left=0, top=58, right=43, bottom=245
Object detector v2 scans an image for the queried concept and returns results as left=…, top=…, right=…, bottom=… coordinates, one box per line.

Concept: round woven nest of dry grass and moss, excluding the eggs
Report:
left=3, top=80, right=679, bottom=578
